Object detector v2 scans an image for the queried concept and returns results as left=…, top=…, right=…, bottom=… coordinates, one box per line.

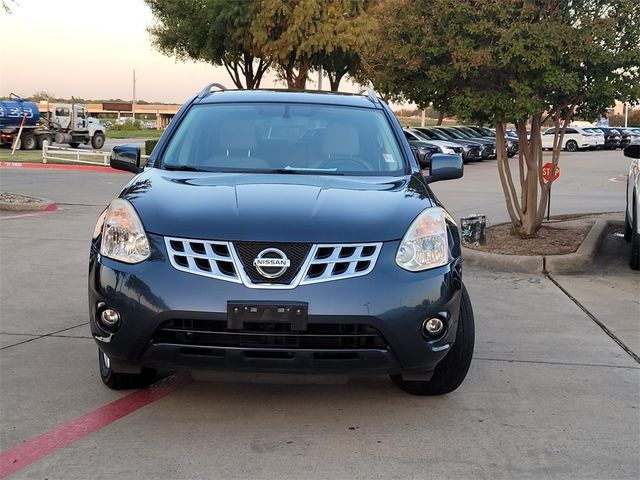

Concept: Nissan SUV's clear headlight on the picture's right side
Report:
left=396, top=207, right=449, bottom=272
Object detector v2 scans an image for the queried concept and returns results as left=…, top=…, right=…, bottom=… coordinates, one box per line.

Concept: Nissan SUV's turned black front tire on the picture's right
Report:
left=391, top=285, right=475, bottom=395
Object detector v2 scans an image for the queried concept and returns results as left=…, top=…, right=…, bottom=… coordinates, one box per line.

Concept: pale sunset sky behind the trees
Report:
left=0, top=0, right=355, bottom=103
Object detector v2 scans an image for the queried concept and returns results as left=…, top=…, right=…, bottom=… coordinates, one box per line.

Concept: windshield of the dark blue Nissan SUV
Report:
left=162, top=103, right=405, bottom=175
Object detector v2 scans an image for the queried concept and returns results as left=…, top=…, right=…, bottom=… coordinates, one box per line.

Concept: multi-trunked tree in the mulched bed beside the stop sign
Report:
left=362, top=0, right=640, bottom=237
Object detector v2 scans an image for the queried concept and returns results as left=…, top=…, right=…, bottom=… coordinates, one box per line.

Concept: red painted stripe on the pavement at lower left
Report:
left=0, top=374, right=191, bottom=478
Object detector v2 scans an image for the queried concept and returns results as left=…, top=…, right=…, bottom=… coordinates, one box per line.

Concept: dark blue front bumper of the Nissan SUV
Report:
left=89, top=235, right=461, bottom=378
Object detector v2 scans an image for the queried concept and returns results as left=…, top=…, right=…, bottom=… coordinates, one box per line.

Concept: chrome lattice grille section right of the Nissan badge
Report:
left=301, top=243, right=382, bottom=285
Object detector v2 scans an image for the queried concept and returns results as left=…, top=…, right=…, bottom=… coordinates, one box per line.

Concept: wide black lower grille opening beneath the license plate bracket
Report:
left=153, top=319, right=388, bottom=350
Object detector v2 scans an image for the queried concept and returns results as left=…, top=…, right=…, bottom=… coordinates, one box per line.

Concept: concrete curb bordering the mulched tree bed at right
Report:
left=462, top=219, right=622, bottom=273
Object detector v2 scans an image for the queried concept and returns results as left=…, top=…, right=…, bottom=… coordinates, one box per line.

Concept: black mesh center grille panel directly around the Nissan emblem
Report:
left=233, top=242, right=311, bottom=285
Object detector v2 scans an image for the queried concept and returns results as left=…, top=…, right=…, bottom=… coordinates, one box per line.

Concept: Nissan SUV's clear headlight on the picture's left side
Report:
left=100, top=198, right=150, bottom=263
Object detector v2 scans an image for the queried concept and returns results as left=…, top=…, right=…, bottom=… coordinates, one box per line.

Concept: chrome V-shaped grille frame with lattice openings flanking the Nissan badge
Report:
left=164, top=237, right=382, bottom=289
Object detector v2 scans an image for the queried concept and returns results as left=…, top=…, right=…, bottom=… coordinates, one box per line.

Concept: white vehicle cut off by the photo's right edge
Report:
left=624, top=143, right=640, bottom=270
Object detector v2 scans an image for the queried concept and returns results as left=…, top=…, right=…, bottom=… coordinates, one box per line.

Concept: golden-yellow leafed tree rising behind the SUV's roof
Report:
left=251, top=0, right=371, bottom=90
